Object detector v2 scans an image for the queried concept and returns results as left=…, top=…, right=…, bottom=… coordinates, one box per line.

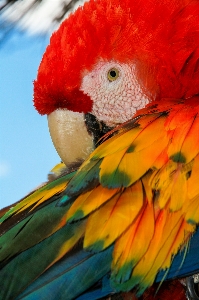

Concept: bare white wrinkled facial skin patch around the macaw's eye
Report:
left=80, top=61, right=149, bottom=126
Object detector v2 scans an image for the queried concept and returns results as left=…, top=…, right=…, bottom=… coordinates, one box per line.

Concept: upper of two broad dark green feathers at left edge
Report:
left=0, top=201, right=68, bottom=262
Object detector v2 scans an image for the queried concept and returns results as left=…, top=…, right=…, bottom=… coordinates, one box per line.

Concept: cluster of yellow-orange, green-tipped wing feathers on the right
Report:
left=61, top=100, right=199, bottom=292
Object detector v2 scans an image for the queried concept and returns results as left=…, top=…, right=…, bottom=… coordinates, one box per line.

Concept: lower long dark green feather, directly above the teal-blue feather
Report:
left=0, top=218, right=84, bottom=300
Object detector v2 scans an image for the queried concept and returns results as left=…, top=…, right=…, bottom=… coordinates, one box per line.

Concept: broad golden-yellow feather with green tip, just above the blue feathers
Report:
left=84, top=182, right=143, bottom=249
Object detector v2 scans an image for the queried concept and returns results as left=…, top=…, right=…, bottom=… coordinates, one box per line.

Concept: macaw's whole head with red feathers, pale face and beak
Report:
left=34, top=0, right=199, bottom=163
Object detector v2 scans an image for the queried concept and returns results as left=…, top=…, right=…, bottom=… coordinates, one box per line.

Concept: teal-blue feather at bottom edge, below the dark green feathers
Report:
left=17, top=247, right=113, bottom=300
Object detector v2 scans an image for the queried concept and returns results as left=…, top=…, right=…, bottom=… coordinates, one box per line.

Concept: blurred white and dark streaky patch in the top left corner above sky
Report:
left=0, top=0, right=85, bottom=43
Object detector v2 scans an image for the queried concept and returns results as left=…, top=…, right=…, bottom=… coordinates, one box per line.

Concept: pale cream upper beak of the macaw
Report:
left=48, top=109, right=94, bottom=165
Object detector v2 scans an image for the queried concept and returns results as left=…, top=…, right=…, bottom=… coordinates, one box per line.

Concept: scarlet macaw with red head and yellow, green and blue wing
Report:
left=0, top=0, right=199, bottom=299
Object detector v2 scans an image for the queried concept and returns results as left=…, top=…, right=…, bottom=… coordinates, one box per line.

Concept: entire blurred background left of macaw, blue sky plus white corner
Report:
left=0, top=0, right=84, bottom=208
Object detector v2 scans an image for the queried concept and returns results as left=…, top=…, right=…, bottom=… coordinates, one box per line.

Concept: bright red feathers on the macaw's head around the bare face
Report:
left=34, top=0, right=199, bottom=114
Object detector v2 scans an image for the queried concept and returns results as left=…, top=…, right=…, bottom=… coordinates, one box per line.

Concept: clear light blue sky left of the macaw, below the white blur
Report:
left=0, top=33, right=60, bottom=208
